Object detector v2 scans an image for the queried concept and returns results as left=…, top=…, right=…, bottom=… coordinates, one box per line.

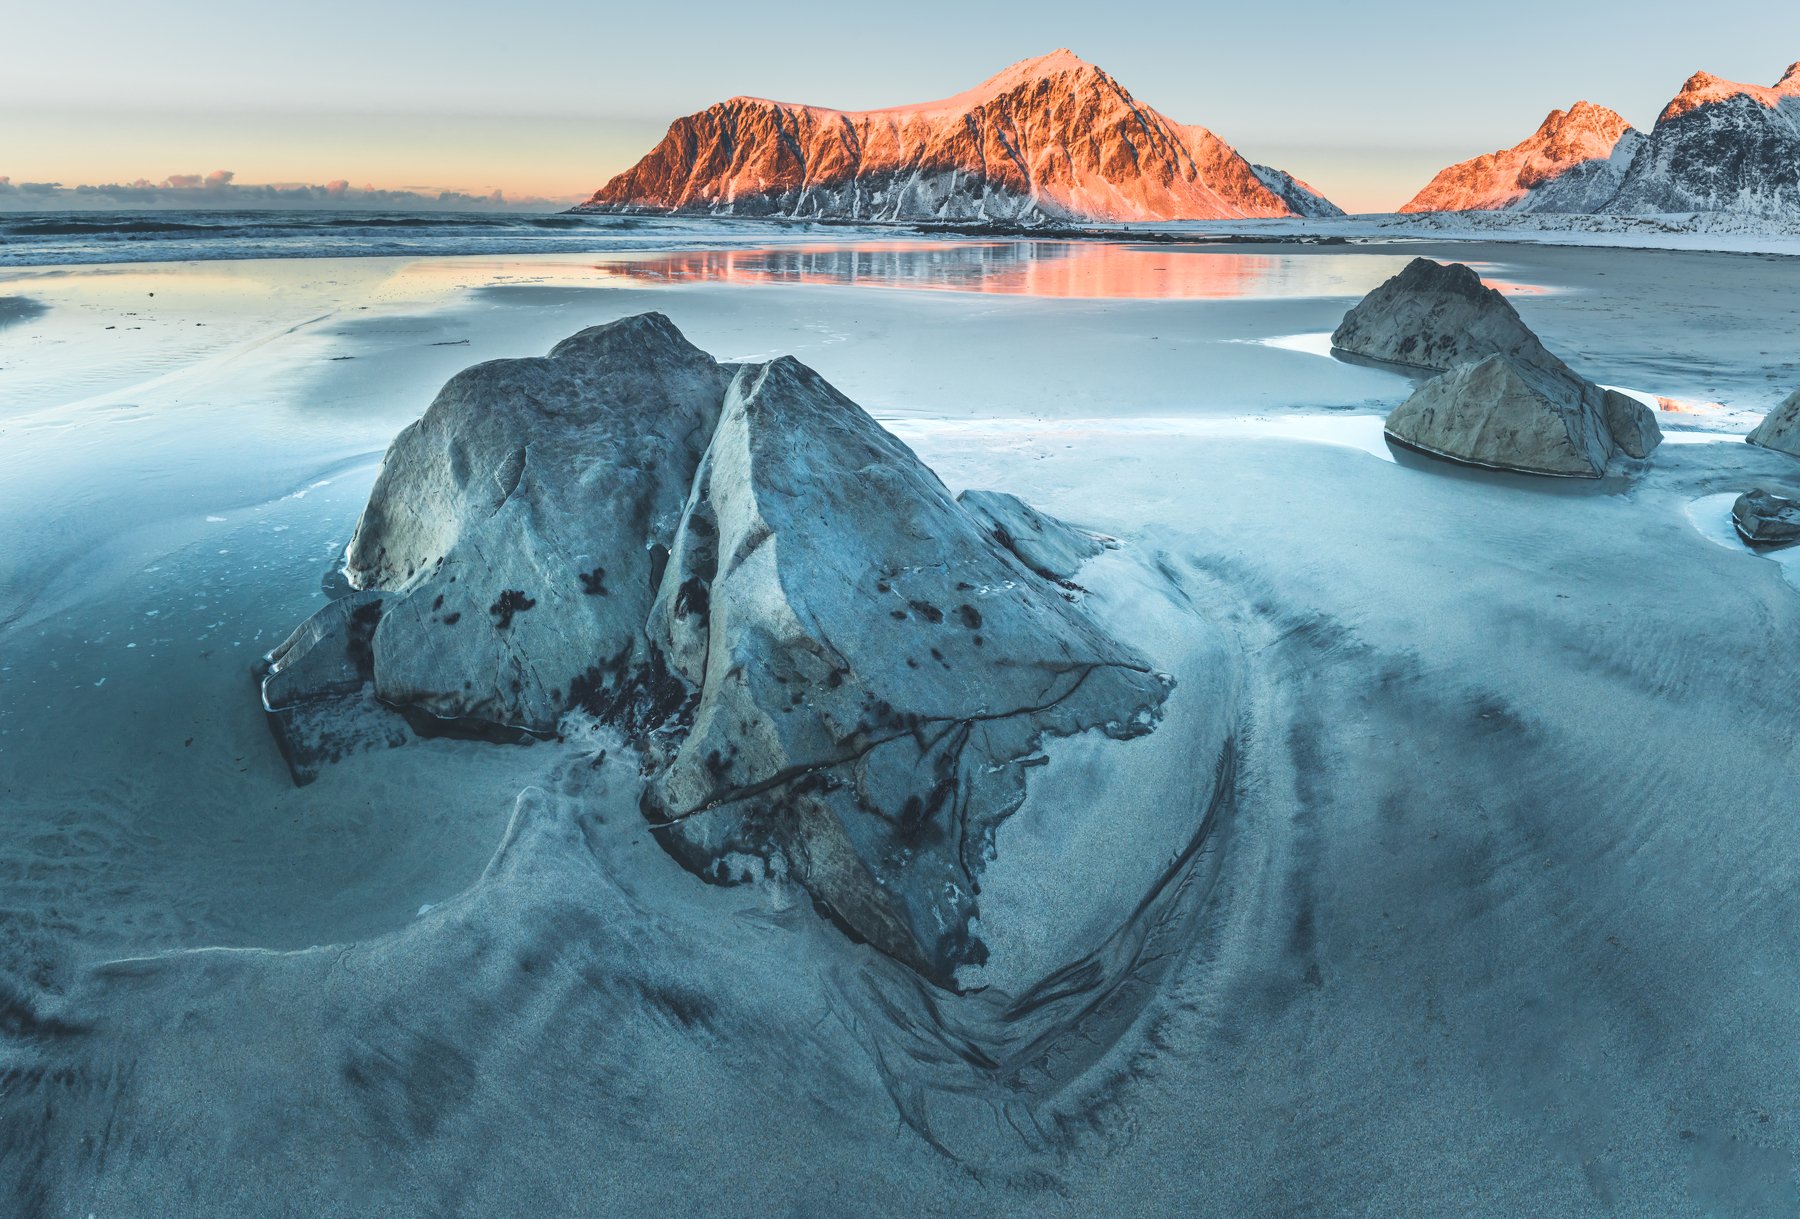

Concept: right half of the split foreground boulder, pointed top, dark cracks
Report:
left=648, top=358, right=1163, bottom=978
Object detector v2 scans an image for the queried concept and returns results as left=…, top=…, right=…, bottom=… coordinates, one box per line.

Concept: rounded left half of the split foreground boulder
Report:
left=346, top=313, right=731, bottom=733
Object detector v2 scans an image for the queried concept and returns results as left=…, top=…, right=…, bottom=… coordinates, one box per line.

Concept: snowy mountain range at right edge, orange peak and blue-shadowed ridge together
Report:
left=1402, top=63, right=1800, bottom=221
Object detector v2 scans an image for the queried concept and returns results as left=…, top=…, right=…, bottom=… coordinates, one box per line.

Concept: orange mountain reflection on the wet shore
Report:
left=619, top=241, right=1432, bottom=299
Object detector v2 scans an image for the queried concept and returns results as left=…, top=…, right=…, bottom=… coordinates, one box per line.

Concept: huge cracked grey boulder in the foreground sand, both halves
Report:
left=265, top=313, right=1180, bottom=983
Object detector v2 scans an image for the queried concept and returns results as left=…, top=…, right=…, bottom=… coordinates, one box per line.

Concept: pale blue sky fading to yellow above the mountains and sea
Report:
left=0, top=0, right=1800, bottom=209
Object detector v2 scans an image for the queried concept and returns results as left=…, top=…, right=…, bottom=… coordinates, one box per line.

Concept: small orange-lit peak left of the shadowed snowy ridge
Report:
left=1400, top=101, right=1631, bottom=212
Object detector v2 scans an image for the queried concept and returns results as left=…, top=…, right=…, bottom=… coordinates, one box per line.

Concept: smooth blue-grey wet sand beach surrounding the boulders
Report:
left=0, top=238, right=1800, bottom=1215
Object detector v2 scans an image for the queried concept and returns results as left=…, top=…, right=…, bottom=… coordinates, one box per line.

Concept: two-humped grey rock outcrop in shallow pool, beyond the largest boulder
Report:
left=1332, top=257, right=1661, bottom=477
